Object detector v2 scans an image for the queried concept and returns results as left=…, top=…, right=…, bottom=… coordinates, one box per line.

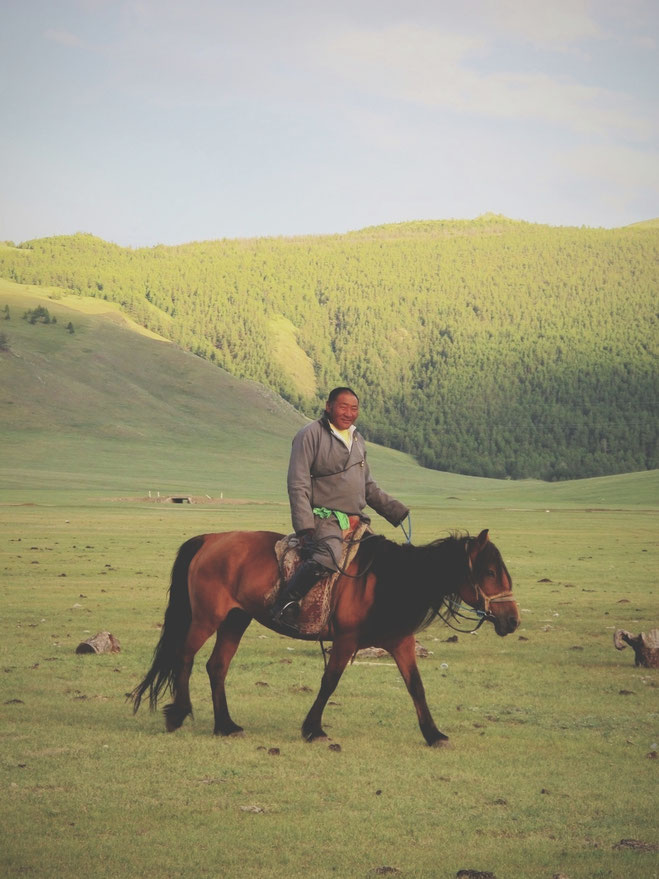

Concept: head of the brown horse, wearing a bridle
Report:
left=460, top=530, right=520, bottom=635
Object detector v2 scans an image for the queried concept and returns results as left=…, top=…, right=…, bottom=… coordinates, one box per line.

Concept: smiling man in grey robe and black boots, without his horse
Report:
left=272, top=388, right=409, bottom=626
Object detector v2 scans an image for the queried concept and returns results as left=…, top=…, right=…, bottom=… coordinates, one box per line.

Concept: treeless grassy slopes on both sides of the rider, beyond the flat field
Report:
left=0, top=281, right=659, bottom=525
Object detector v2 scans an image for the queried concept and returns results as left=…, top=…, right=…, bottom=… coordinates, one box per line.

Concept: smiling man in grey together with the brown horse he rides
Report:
left=131, top=388, right=519, bottom=747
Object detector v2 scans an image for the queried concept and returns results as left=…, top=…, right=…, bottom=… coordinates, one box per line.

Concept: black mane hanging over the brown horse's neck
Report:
left=358, top=533, right=470, bottom=632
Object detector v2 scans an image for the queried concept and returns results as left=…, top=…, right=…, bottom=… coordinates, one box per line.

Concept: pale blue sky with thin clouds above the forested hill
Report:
left=0, top=0, right=659, bottom=247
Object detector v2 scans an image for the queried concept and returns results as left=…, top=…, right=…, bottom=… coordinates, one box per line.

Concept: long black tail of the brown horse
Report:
left=128, top=535, right=204, bottom=713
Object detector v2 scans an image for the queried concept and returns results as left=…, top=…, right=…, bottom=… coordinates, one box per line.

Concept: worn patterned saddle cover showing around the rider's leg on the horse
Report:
left=266, top=516, right=371, bottom=636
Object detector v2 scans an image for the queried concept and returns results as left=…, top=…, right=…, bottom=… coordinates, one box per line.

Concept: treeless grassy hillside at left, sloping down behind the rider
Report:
left=0, top=281, right=304, bottom=497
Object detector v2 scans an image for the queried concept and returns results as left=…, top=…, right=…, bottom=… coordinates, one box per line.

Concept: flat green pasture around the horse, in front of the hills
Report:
left=0, top=484, right=659, bottom=879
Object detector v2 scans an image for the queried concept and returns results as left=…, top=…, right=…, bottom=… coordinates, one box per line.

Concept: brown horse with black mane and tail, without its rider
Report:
left=130, top=531, right=519, bottom=746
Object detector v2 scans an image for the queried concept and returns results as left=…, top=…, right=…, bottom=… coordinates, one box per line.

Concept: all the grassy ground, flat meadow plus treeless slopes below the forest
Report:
left=0, top=282, right=659, bottom=879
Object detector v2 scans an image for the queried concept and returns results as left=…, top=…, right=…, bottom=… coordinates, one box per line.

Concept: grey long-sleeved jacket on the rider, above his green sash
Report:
left=288, top=416, right=409, bottom=531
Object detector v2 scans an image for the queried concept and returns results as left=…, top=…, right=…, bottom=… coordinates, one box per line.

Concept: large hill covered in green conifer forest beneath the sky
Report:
left=0, top=215, right=659, bottom=479
